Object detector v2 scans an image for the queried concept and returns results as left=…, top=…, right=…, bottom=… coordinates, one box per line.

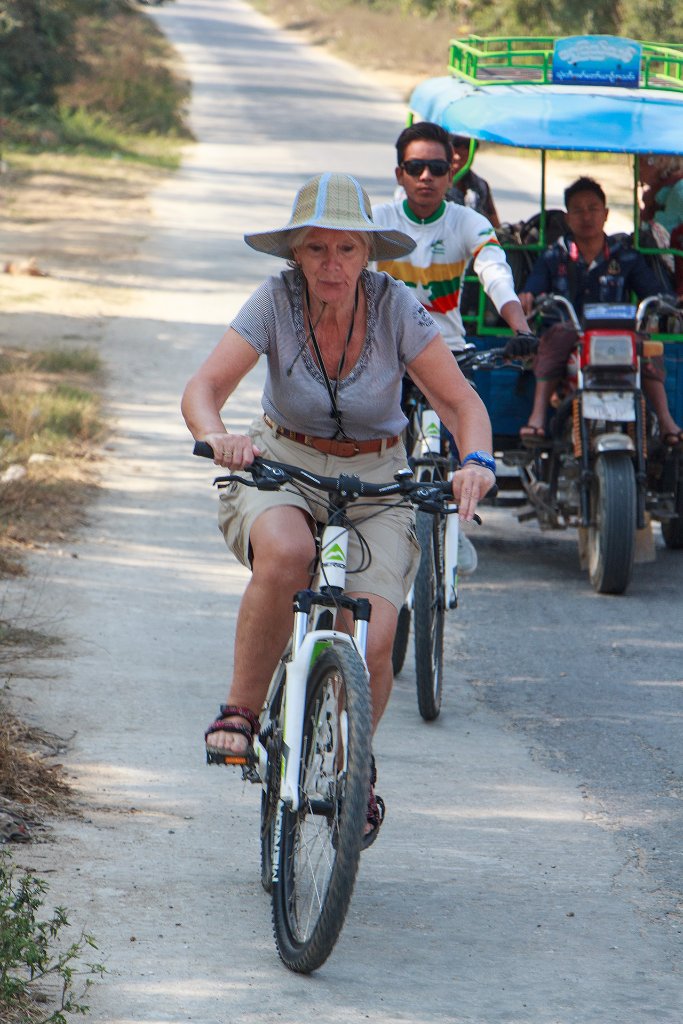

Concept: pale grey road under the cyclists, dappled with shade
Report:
left=2, top=0, right=682, bottom=1024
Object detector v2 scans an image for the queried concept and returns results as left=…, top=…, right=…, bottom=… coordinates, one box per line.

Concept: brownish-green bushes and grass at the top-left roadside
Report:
left=0, top=0, right=191, bottom=166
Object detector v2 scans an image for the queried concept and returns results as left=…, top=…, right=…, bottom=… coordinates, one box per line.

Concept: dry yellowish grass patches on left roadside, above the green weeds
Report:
left=0, top=347, right=102, bottom=824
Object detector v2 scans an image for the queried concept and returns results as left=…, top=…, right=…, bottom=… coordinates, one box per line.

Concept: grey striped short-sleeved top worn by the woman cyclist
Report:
left=231, top=269, right=438, bottom=440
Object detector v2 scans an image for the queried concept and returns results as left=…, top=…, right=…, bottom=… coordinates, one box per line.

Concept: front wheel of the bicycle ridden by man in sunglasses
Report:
left=413, top=512, right=445, bottom=722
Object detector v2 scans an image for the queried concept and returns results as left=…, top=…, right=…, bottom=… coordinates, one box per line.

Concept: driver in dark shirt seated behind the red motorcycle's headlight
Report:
left=519, top=177, right=683, bottom=447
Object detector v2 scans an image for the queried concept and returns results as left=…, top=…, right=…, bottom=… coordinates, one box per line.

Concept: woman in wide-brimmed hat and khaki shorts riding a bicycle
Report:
left=182, top=174, right=495, bottom=838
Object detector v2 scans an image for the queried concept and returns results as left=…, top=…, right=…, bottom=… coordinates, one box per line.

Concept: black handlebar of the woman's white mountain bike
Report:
left=194, top=441, right=481, bottom=522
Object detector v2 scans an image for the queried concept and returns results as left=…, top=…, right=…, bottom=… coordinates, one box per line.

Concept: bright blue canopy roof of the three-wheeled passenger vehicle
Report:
left=410, top=76, right=683, bottom=153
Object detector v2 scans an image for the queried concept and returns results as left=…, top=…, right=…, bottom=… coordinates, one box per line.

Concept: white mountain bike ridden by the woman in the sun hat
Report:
left=195, top=441, right=457, bottom=974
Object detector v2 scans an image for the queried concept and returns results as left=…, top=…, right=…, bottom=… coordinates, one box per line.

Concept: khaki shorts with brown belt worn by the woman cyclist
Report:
left=218, top=419, right=420, bottom=608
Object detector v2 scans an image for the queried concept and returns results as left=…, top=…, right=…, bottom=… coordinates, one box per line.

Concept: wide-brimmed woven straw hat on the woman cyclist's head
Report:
left=245, top=173, right=415, bottom=259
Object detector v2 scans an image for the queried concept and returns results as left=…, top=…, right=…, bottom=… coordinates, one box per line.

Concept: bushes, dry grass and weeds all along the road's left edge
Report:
left=0, top=6, right=187, bottom=1024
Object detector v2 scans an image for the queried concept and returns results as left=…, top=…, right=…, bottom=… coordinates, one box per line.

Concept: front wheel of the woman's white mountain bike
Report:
left=272, top=645, right=372, bottom=974
